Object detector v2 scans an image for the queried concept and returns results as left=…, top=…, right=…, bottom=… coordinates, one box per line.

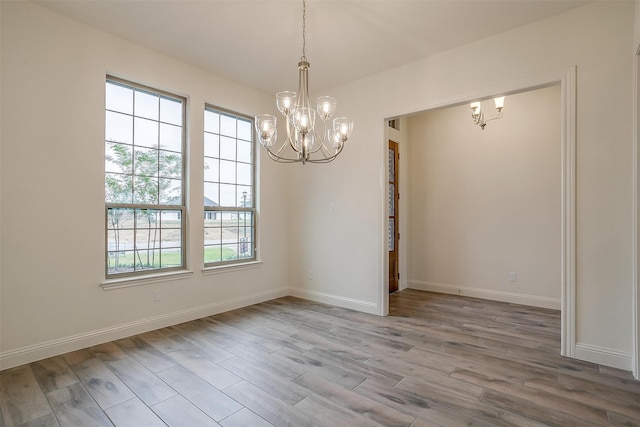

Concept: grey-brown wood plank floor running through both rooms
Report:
left=0, top=290, right=640, bottom=427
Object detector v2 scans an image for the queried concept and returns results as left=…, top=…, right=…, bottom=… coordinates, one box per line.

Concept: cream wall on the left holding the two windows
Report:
left=0, top=2, right=289, bottom=367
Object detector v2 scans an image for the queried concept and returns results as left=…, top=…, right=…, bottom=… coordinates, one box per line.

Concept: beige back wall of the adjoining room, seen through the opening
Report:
left=407, top=85, right=562, bottom=309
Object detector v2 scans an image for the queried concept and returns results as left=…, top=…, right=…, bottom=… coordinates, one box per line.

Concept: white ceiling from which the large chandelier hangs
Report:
left=34, top=0, right=589, bottom=92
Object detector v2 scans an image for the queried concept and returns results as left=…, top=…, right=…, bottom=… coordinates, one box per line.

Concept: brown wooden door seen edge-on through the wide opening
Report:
left=389, top=141, right=400, bottom=293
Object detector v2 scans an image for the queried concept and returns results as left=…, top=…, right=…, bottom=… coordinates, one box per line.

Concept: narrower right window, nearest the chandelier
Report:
left=204, top=106, right=256, bottom=266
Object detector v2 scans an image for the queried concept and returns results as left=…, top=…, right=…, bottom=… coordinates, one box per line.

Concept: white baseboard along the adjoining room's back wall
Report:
left=407, top=280, right=560, bottom=310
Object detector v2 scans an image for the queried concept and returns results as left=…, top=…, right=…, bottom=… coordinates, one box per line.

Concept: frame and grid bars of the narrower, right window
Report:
left=202, top=103, right=258, bottom=270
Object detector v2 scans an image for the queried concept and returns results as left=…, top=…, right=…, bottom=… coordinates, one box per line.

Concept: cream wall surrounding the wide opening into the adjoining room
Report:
left=291, top=1, right=634, bottom=369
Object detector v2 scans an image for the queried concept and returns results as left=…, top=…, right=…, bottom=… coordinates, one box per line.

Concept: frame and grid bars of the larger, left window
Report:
left=104, top=75, right=188, bottom=282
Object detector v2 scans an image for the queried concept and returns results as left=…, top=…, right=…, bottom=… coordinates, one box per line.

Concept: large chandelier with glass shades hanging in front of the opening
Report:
left=255, top=0, right=353, bottom=164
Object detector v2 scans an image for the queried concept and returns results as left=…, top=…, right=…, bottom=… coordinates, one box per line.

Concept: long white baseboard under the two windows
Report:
left=0, top=288, right=289, bottom=370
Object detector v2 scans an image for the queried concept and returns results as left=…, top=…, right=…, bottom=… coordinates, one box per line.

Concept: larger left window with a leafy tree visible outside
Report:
left=105, top=77, right=185, bottom=278
